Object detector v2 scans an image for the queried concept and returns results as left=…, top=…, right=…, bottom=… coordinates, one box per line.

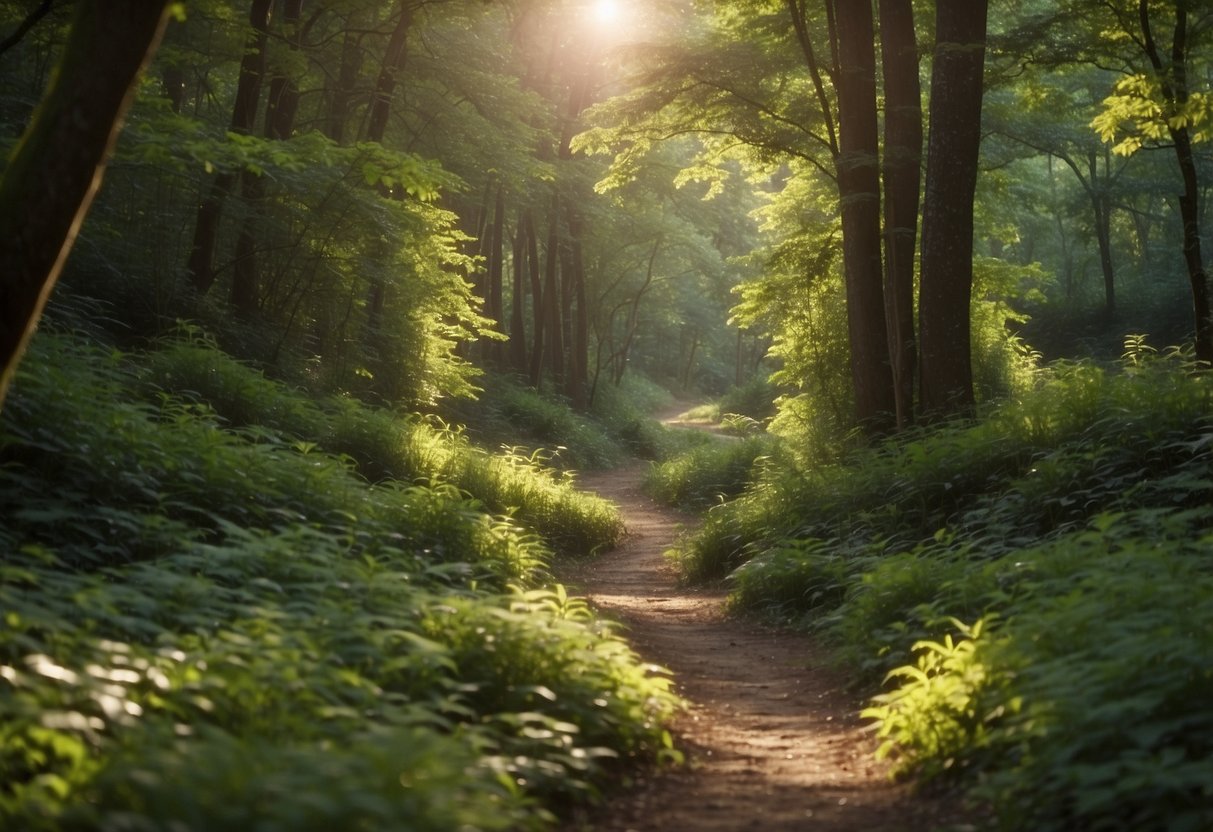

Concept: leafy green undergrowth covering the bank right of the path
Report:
left=680, top=340, right=1213, bottom=830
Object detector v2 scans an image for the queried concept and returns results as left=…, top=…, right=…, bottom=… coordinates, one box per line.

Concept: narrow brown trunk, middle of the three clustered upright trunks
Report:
left=879, top=0, right=922, bottom=428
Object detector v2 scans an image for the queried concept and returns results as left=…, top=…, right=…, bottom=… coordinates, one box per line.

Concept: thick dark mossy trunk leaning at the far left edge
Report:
left=0, top=0, right=167, bottom=405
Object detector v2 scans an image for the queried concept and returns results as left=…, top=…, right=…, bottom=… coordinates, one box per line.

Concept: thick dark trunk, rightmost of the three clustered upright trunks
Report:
left=918, top=0, right=987, bottom=418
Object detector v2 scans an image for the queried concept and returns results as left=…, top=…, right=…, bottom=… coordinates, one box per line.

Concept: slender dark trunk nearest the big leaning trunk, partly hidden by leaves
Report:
left=186, top=0, right=274, bottom=295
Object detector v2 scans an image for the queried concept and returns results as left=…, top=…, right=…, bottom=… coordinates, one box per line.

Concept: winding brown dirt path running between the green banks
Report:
left=559, top=414, right=972, bottom=832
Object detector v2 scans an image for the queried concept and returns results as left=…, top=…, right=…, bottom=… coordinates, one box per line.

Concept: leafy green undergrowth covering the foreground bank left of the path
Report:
left=0, top=334, right=676, bottom=831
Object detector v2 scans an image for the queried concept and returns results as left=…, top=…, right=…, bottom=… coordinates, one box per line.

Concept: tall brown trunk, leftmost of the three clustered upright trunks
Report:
left=837, top=1, right=896, bottom=433
